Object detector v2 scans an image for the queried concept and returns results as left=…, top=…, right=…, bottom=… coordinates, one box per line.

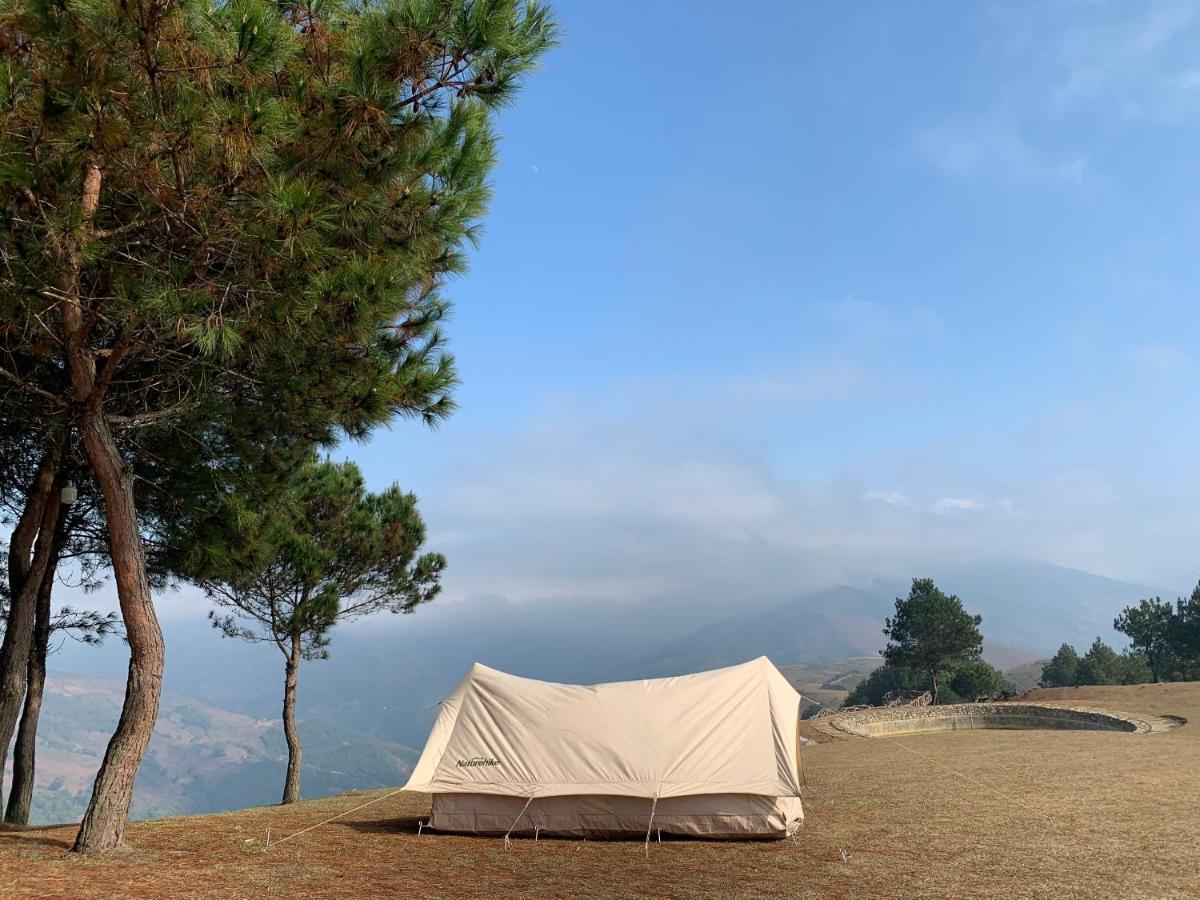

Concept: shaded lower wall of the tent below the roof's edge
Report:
left=430, top=793, right=803, bottom=838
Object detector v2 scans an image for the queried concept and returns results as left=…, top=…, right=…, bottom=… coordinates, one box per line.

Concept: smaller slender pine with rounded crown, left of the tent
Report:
left=177, top=458, right=445, bottom=803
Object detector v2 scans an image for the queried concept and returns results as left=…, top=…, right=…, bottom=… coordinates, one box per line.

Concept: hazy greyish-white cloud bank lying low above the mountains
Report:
left=400, top=362, right=1196, bottom=610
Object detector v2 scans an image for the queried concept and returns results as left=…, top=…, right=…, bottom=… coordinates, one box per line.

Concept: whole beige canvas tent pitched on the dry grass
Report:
left=404, top=656, right=803, bottom=838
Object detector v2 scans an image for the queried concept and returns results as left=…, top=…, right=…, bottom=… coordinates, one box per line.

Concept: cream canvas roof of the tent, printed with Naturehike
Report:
left=404, top=656, right=800, bottom=797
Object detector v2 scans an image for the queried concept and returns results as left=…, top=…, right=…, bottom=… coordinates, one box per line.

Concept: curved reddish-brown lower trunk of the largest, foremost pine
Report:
left=74, top=414, right=164, bottom=853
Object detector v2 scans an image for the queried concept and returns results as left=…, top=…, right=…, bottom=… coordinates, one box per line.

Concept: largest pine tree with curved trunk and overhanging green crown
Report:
left=0, top=0, right=556, bottom=851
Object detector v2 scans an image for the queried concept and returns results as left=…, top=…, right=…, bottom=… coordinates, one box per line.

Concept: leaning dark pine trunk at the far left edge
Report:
left=0, top=467, right=60, bottom=811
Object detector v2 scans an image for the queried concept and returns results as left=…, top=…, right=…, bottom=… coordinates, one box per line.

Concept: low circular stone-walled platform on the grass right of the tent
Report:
left=826, top=702, right=1187, bottom=738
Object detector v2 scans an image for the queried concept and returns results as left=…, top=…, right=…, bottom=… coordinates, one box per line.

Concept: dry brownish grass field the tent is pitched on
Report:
left=0, top=683, right=1200, bottom=898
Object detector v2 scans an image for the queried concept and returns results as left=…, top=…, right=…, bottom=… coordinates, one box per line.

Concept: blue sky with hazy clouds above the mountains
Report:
left=337, top=0, right=1200, bottom=602
